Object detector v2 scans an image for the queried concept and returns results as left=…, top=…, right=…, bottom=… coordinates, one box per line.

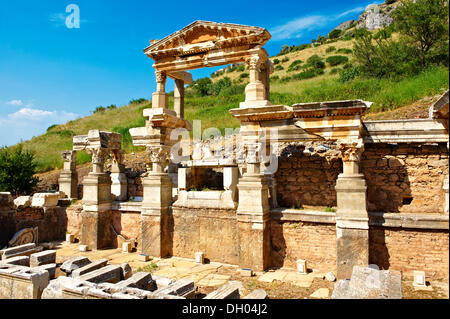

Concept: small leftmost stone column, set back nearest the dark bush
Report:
left=58, top=151, right=78, bottom=199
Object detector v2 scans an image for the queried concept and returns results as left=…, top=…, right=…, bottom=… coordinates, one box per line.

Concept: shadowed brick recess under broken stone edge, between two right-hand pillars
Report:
left=275, top=143, right=342, bottom=207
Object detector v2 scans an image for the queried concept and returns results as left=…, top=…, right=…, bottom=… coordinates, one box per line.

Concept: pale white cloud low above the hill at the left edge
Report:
left=0, top=107, right=79, bottom=147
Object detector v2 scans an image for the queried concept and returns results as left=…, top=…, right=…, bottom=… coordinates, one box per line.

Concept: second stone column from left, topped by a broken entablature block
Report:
left=81, top=147, right=112, bottom=249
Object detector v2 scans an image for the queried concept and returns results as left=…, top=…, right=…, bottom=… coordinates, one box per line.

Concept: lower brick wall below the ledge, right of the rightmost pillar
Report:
left=370, top=227, right=449, bottom=281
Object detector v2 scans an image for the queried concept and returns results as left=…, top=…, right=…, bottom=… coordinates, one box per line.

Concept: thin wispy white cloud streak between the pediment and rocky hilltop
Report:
left=270, top=7, right=364, bottom=41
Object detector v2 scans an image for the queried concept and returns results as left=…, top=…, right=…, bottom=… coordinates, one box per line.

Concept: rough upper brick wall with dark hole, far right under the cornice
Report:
left=361, top=143, right=448, bottom=213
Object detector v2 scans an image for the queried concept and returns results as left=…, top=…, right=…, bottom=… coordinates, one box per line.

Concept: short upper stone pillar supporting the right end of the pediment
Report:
left=240, top=55, right=271, bottom=108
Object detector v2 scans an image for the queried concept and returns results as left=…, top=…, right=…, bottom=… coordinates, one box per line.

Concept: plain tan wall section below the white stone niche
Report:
left=168, top=207, right=239, bottom=264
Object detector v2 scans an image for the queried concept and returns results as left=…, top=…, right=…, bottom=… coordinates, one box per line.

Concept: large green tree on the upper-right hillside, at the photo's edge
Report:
left=393, top=0, right=449, bottom=68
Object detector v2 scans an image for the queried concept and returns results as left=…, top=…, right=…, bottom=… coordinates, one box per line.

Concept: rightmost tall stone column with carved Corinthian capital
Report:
left=336, top=140, right=369, bottom=279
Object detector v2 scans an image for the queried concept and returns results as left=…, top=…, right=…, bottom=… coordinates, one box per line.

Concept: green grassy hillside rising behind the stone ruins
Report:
left=12, top=34, right=449, bottom=171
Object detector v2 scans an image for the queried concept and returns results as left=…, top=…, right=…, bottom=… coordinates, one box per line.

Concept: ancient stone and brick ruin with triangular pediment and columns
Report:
left=0, top=21, right=449, bottom=298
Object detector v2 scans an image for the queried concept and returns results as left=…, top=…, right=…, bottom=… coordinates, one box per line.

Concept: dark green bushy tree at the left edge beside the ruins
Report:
left=0, top=145, right=39, bottom=196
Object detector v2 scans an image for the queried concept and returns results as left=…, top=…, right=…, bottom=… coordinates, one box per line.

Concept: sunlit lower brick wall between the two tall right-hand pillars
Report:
left=270, top=220, right=337, bottom=271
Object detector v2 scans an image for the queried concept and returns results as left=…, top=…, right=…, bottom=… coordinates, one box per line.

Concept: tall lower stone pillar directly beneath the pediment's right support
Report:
left=237, top=143, right=270, bottom=271
